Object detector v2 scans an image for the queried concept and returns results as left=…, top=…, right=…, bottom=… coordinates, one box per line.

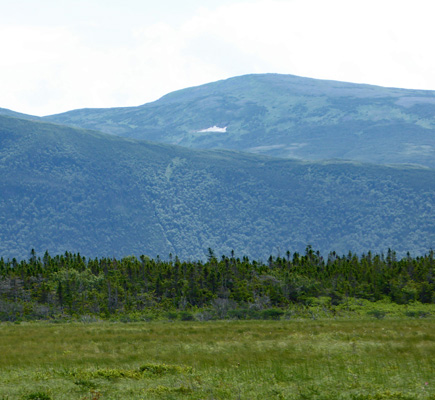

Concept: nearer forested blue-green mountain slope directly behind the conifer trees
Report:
left=0, top=116, right=435, bottom=260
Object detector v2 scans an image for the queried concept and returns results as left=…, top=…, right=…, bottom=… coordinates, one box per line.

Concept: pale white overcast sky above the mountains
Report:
left=0, top=0, right=435, bottom=116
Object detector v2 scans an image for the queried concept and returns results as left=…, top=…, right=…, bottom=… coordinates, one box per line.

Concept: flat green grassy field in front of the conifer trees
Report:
left=0, top=318, right=435, bottom=400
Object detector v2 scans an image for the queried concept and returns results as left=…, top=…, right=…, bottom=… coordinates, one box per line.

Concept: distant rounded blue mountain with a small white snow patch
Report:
left=46, top=74, right=435, bottom=168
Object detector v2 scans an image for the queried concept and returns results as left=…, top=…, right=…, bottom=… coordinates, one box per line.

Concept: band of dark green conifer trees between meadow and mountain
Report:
left=0, top=246, right=435, bottom=322
